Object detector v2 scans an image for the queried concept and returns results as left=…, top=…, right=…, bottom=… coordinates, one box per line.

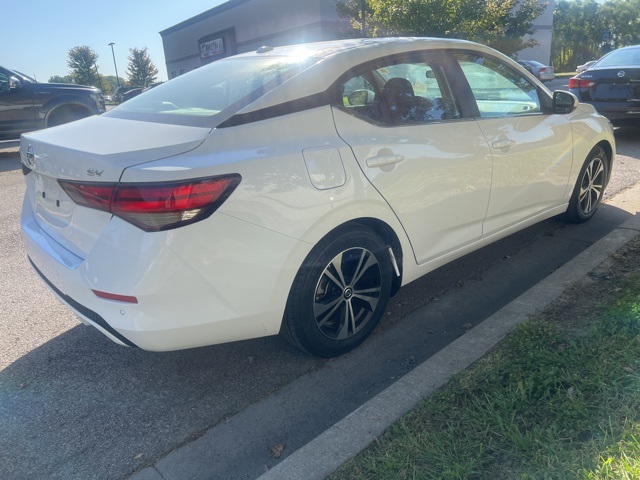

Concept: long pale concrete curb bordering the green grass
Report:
left=259, top=212, right=640, bottom=480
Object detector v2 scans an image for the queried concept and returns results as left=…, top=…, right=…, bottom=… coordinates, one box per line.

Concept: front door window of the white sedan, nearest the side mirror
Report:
left=456, top=53, right=542, bottom=117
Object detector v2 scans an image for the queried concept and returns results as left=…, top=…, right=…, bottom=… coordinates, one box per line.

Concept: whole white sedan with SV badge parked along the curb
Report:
left=20, top=38, right=615, bottom=357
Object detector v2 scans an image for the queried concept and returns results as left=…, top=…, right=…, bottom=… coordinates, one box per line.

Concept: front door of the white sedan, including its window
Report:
left=456, top=53, right=573, bottom=235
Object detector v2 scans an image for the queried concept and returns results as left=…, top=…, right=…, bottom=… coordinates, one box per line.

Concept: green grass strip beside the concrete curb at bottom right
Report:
left=331, top=276, right=640, bottom=480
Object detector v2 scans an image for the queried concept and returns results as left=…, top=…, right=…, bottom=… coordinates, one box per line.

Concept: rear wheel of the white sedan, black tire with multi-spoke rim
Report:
left=282, top=225, right=393, bottom=358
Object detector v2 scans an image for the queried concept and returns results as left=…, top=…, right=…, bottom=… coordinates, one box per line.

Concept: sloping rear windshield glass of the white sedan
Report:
left=106, top=57, right=318, bottom=126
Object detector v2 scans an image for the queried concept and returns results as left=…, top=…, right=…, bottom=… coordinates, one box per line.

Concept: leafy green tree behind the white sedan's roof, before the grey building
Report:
left=336, top=0, right=544, bottom=55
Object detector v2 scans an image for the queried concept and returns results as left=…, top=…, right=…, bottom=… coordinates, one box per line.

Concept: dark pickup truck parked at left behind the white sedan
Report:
left=0, top=67, right=105, bottom=140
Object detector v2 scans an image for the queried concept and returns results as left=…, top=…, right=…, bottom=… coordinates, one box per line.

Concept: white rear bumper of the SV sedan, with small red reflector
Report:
left=21, top=196, right=307, bottom=351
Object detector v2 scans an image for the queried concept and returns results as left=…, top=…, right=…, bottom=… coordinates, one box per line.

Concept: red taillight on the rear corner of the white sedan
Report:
left=59, top=174, right=242, bottom=232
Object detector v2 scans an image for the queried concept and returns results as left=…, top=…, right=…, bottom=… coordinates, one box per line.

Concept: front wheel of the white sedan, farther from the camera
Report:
left=565, top=146, right=609, bottom=223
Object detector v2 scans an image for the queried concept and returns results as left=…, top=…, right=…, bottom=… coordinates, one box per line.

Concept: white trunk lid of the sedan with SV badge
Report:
left=20, top=116, right=210, bottom=258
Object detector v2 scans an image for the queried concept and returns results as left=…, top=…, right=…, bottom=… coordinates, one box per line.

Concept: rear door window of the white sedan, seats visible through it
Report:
left=342, top=55, right=461, bottom=125
